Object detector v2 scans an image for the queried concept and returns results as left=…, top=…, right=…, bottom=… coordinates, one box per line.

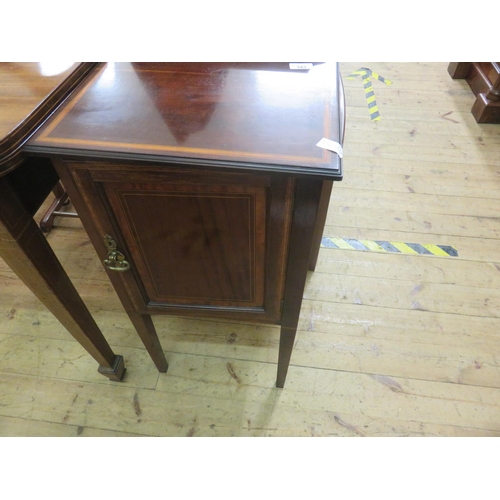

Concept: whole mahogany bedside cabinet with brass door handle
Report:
left=25, top=63, right=344, bottom=387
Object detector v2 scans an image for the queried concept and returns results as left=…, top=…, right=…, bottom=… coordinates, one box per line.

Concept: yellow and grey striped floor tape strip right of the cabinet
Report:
left=321, top=236, right=458, bottom=257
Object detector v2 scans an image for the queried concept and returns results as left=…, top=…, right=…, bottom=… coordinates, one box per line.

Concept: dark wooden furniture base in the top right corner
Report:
left=448, top=62, right=500, bottom=123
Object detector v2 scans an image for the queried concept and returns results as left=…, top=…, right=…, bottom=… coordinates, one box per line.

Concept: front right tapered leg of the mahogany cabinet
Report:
left=276, top=178, right=323, bottom=387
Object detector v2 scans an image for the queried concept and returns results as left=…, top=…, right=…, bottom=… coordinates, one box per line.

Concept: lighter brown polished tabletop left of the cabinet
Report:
left=0, top=61, right=96, bottom=175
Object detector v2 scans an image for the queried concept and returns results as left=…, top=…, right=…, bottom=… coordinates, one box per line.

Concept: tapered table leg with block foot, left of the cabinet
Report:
left=0, top=178, right=125, bottom=381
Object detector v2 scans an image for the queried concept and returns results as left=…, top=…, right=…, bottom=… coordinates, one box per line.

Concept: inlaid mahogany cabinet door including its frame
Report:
left=67, top=162, right=293, bottom=323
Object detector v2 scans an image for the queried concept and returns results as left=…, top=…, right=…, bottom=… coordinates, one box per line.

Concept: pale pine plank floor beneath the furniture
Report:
left=0, top=63, right=500, bottom=436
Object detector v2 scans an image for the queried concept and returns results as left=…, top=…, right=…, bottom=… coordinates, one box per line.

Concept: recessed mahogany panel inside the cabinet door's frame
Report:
left=104, top=182, right=266, bottom=307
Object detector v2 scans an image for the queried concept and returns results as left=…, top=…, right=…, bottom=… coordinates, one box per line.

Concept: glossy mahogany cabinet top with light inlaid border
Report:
left=26, top=63, right=344, bottom=179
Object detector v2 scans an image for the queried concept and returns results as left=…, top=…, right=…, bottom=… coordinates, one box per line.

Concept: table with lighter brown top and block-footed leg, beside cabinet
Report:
left=0, top=63, right=125, bottom=380
